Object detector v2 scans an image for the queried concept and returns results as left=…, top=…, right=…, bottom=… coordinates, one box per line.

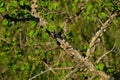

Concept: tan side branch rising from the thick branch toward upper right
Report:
left=86, top=12, right=117, bottom=58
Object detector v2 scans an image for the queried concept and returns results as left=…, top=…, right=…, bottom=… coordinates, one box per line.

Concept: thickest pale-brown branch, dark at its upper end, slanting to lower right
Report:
left=51, top=30, right=109, bottom=80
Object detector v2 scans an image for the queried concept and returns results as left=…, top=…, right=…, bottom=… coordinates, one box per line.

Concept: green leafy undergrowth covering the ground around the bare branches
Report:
left=0, top=0, right=120, bottom=80
